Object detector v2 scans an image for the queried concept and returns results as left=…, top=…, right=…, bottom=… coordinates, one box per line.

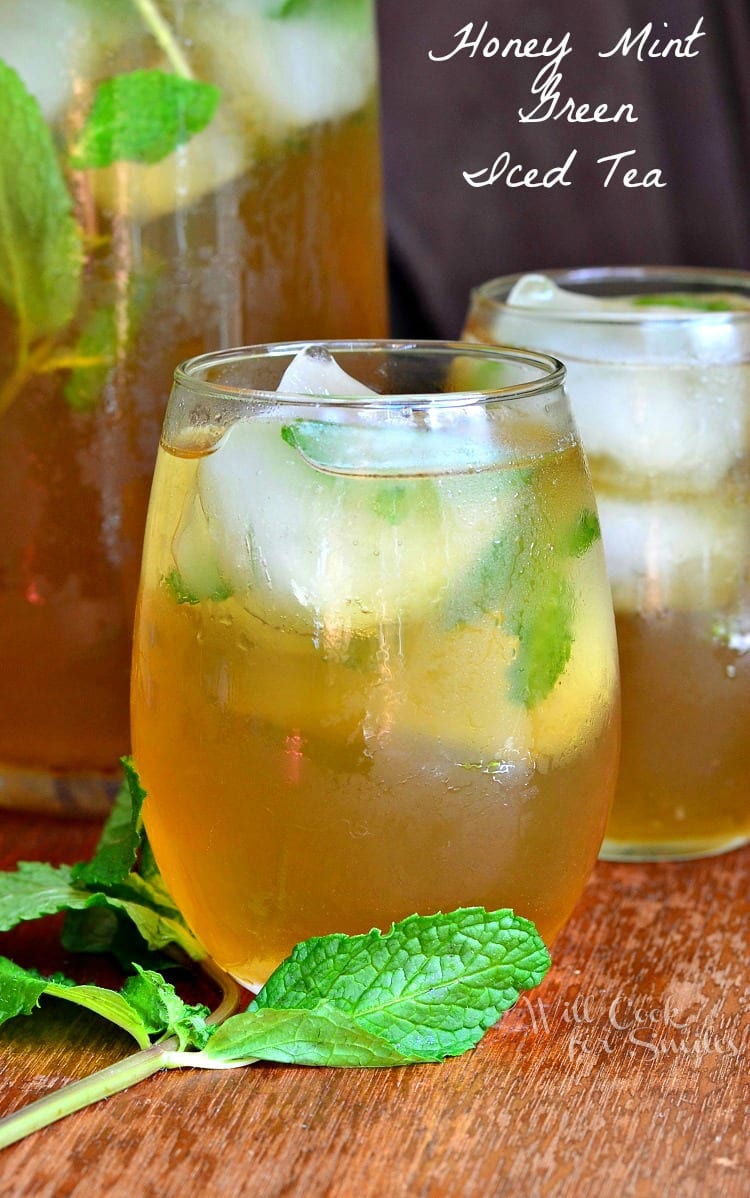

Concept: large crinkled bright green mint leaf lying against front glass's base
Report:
left=207, top=907, right=550, bottom=1065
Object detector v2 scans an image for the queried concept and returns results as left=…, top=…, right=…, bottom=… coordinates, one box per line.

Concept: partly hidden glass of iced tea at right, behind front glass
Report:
left=466, top=267, right=750, bottom=860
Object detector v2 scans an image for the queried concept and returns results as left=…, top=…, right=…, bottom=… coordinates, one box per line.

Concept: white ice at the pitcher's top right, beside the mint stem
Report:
left=186, top=0, right=376, bottom=139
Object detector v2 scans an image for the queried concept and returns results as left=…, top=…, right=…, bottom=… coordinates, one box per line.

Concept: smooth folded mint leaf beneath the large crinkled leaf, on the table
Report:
left=204, top=1004, right=424, bottom=1069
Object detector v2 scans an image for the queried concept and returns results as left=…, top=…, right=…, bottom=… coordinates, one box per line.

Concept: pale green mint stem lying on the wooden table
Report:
left=0, top=958, right=240, bottom=1149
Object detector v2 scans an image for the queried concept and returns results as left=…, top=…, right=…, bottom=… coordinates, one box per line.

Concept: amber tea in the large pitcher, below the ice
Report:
left=0, top=103, right=386, bottom=809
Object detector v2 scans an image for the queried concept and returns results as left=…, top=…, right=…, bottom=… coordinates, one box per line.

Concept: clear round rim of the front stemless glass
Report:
left=174, top=339, right=565, bottom=411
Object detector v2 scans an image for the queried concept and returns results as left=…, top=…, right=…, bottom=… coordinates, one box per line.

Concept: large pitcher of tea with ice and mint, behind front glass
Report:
left=0, top=0, right=386, bottom=812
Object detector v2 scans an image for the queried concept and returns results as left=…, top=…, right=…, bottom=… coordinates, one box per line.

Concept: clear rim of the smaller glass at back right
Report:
left=470, top=266, right=750, bottom=327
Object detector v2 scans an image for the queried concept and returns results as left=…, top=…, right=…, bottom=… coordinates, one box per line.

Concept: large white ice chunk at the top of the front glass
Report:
left=198, top=355, right=514, bottom=639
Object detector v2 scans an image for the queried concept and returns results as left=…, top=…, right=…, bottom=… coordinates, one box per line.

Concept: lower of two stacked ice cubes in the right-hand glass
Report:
left=598, top=495, right=750, bottom=612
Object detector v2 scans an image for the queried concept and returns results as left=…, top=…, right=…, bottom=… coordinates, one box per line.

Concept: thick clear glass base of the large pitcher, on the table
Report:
left=0, top=764, right=122, bottom=819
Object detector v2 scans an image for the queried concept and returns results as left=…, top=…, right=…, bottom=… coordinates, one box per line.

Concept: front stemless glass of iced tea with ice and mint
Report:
left=132, top=341, right=618, bottom=986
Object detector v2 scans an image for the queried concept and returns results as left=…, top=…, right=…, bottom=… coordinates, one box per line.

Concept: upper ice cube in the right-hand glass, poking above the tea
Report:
left=491, top=274, right=750, bottom=492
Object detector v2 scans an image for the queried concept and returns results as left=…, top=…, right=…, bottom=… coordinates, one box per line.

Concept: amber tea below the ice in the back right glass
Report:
left=606, top=612, right=750, bottom=857
